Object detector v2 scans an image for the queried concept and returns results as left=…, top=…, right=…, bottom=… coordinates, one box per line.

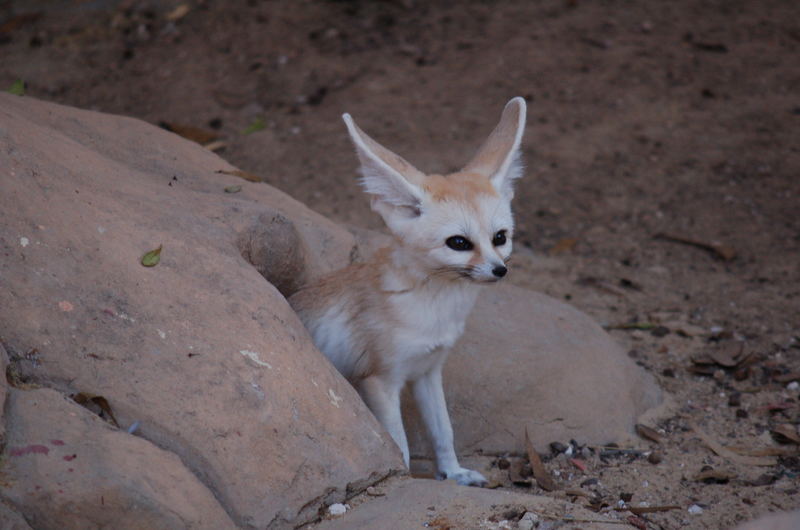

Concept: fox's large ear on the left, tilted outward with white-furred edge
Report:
left=342, top=114, right=425, bottom=215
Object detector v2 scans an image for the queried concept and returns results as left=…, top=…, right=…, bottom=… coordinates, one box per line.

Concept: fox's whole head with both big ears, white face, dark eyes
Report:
left=343, top=97, right=525, bottom=282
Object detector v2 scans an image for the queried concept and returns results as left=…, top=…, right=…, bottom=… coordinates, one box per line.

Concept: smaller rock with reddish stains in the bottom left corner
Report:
left=2, top=388, right=236, bottom=530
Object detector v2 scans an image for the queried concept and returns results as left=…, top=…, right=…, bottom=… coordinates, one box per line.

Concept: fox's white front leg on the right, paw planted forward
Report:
left=413, top=364, right=486, bottom=486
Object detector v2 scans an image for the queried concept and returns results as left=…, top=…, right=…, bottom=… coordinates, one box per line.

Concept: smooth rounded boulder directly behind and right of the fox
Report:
left=408, top=285, right=661, bottom=455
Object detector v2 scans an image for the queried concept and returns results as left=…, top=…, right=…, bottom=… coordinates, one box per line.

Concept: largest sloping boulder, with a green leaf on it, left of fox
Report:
left=0, top=94, right=402, bottom=528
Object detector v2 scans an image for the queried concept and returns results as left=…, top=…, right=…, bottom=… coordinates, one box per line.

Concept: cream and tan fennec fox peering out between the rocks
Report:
left=289, top=97, right=525, bottom=486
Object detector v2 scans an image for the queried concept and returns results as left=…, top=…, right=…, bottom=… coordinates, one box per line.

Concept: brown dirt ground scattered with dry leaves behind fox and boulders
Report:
left=0, top=0, right=800, bottom=528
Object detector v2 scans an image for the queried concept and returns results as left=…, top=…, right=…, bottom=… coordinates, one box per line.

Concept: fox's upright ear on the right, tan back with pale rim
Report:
left=463, top=97, right=526, bottom=199
